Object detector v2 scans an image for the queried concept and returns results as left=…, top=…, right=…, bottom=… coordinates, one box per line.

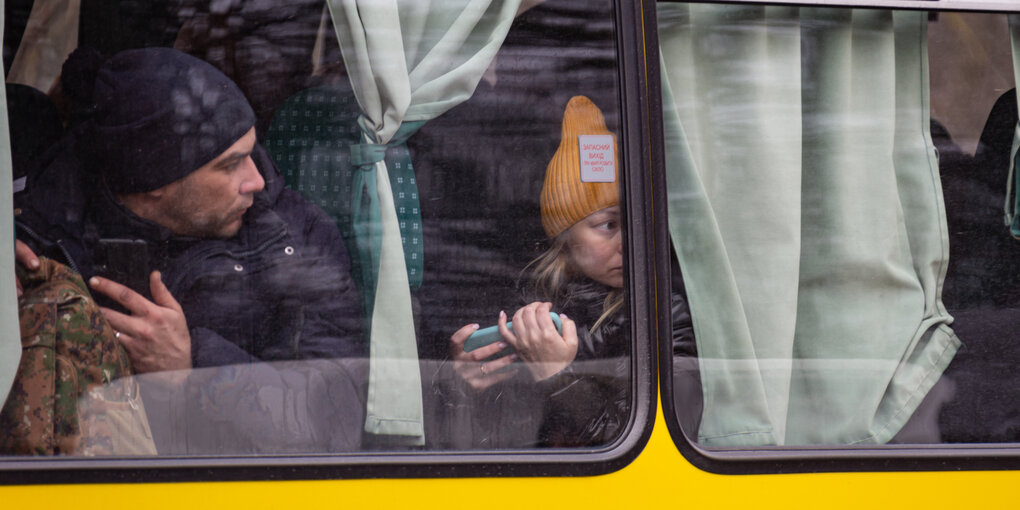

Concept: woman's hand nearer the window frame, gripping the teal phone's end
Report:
left=499, top=302, right=577, bottom=380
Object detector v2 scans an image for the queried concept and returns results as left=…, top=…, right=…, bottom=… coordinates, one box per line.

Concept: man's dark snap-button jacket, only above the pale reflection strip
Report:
left=16, top=137, right=367, bottom=367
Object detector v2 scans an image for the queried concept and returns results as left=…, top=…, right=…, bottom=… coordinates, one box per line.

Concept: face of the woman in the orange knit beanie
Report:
left=567, top=206, right=623, bottom=289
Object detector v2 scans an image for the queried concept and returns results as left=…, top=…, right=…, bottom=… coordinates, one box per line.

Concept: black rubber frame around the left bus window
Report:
left=0, top=0, right=665, bottom=486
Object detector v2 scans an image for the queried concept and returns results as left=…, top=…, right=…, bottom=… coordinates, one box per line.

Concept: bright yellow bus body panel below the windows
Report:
left=0, top=401, right=1020, bottom=510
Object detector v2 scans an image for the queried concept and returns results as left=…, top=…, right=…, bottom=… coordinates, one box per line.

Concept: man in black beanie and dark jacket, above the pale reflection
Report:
left=17, top=48, right=367, bottom=372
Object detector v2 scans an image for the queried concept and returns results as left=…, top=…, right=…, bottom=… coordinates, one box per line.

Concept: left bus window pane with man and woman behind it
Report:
left=0, top=0, right=634, bottom=463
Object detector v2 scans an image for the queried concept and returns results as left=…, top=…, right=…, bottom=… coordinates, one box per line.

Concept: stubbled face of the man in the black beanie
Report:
left=156, top=128, right=265, bottom=239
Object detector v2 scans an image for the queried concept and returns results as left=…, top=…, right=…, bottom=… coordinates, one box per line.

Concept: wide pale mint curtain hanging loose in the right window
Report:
left=659, top=4, right=960, bottom=446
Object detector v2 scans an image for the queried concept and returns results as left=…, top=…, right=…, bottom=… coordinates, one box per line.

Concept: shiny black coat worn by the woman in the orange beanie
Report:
left=426, top=270, right=701, bottom=449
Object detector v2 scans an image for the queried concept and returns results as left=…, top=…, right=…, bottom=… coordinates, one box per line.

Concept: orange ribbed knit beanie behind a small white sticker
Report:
left=542, top=96, right=620, bottom=238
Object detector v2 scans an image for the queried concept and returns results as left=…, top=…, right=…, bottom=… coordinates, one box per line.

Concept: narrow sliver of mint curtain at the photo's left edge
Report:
left=0, top=0, right=21, bottom=407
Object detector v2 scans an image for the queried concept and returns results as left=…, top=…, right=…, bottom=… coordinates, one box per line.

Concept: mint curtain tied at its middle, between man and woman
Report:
left=327, top=0, right=520, bottom=444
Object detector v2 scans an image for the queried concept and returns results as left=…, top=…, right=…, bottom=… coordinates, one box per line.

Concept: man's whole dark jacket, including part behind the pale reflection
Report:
left=15, top=136, right=368, bottom=454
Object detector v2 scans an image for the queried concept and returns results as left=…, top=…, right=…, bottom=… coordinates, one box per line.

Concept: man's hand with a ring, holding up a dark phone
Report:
left=89, top=271, right=192, bottom=373
